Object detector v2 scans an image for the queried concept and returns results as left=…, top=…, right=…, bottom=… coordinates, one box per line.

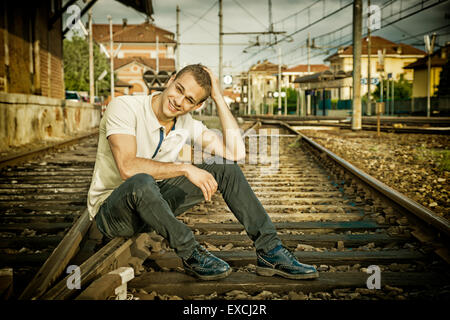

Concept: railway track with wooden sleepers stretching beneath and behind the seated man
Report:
left=0, top=122, right=450, bottom=299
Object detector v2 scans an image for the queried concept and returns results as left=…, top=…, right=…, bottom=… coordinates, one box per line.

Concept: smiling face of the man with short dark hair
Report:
left=157, top=72, right=206, bottom=121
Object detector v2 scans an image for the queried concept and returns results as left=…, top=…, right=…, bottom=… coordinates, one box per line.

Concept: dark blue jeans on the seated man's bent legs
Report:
left=95, top=158, right=281, bottom=259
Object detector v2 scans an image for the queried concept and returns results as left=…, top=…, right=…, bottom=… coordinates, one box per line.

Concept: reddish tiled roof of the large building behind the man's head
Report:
left=92, top=22, right=176, bottom=43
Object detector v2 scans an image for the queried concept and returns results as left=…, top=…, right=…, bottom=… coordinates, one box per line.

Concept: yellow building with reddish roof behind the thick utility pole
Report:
left=324, top=36, right=426, bottom=99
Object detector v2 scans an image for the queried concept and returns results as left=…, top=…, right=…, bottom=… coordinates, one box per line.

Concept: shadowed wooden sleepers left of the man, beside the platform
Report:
left=0, top=135, right=98, bottom=298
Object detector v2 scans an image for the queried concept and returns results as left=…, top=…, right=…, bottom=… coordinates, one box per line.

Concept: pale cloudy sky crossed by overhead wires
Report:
left=67, top=0, right=450, bottom=74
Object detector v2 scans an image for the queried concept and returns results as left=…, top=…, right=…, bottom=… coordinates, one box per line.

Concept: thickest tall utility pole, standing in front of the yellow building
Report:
left=352, top=0, right=362, bottom=130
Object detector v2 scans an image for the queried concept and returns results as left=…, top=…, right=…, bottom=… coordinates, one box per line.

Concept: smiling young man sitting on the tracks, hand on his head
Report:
left=88, top=65, right=318, bottom=280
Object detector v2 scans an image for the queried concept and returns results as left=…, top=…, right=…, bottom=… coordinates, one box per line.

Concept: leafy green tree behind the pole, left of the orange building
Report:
left=63, top=36, right=110, bottom=96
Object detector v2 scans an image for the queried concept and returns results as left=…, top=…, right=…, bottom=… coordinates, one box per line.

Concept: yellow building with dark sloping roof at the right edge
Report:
left=405, top=44, right=450, bottom=98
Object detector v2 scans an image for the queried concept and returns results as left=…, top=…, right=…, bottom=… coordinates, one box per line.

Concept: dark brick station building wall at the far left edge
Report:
left=0, top=1, right=64, bottom=99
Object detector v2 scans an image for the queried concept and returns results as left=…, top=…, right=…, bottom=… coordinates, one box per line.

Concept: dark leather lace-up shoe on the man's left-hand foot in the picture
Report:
left=182, top=245, right=231, bottom=280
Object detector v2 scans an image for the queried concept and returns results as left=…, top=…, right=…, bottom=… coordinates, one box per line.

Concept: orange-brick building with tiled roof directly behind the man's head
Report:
left=92, top=19, right=176, bottom=95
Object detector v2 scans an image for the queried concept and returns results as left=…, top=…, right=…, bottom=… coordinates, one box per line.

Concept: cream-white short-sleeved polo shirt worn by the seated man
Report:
left=87, top=92, right=207, bottom=220
